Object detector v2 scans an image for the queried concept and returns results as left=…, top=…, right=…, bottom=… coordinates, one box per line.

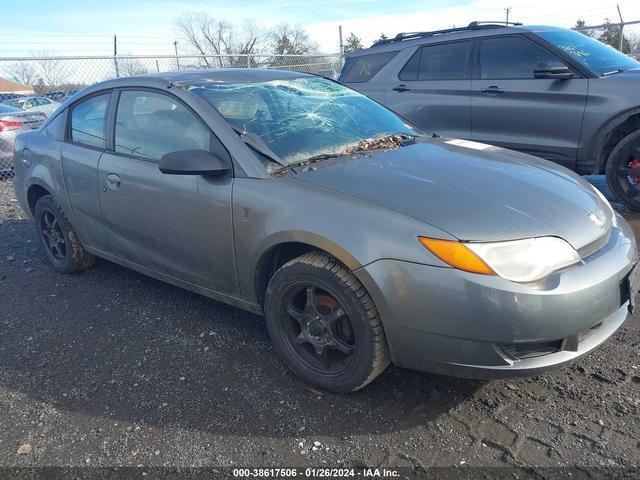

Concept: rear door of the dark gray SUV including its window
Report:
left=386, top=40, right=472, bottom=138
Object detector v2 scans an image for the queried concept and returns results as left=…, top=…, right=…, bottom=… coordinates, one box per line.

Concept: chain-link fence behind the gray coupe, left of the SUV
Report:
left=0, top=54, right=341, bottom=192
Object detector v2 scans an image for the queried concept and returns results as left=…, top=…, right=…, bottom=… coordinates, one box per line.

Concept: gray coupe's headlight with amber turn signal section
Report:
left=418, top=237, right=580, bottom=282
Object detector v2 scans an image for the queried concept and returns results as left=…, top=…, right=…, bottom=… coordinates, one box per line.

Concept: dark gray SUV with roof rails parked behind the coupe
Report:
left=339, top=22, right=640, bottom=211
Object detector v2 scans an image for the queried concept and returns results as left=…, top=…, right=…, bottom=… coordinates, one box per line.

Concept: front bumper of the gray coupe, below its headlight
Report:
left=356, top=218, right=637, bottom=378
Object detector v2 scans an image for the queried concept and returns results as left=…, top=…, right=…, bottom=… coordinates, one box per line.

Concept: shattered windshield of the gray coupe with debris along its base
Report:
left=190, top=78, right=422, bottom=165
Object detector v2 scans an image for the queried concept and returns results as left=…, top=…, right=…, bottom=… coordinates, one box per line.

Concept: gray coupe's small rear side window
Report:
left=71, top=93, right=111, bottom=148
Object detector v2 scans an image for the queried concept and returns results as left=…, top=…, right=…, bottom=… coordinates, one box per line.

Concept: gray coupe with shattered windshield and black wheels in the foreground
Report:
left=14, top=70, right=638, bottom=392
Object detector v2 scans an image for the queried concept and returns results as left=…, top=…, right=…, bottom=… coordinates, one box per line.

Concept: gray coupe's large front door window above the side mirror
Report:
left=115, top=90, right=212, bottom=160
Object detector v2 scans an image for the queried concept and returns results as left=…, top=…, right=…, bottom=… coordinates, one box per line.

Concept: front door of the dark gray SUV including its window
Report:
left=471, top=35, right=588, bottom=168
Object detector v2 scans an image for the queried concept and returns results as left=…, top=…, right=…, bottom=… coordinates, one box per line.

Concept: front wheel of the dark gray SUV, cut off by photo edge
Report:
left=606, top=130, right=640, bottom=212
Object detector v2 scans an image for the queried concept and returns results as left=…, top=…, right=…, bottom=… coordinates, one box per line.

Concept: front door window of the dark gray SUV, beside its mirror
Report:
left=480, top=36, right=559, bottom=80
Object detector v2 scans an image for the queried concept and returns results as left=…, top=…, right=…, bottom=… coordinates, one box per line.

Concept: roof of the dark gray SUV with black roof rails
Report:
left=348, top=22, right=564, bottom=57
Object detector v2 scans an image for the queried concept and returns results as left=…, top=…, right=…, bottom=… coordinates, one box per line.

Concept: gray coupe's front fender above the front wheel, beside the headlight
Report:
left=233, top=177, right=454, bottom=302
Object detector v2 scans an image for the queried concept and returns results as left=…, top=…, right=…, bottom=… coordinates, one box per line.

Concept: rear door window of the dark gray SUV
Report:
left=398, top=42, right=471, bottom=80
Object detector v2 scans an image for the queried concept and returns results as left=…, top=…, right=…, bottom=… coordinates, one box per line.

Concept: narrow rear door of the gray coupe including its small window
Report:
left=60, top=91, right=111, bottom=249
